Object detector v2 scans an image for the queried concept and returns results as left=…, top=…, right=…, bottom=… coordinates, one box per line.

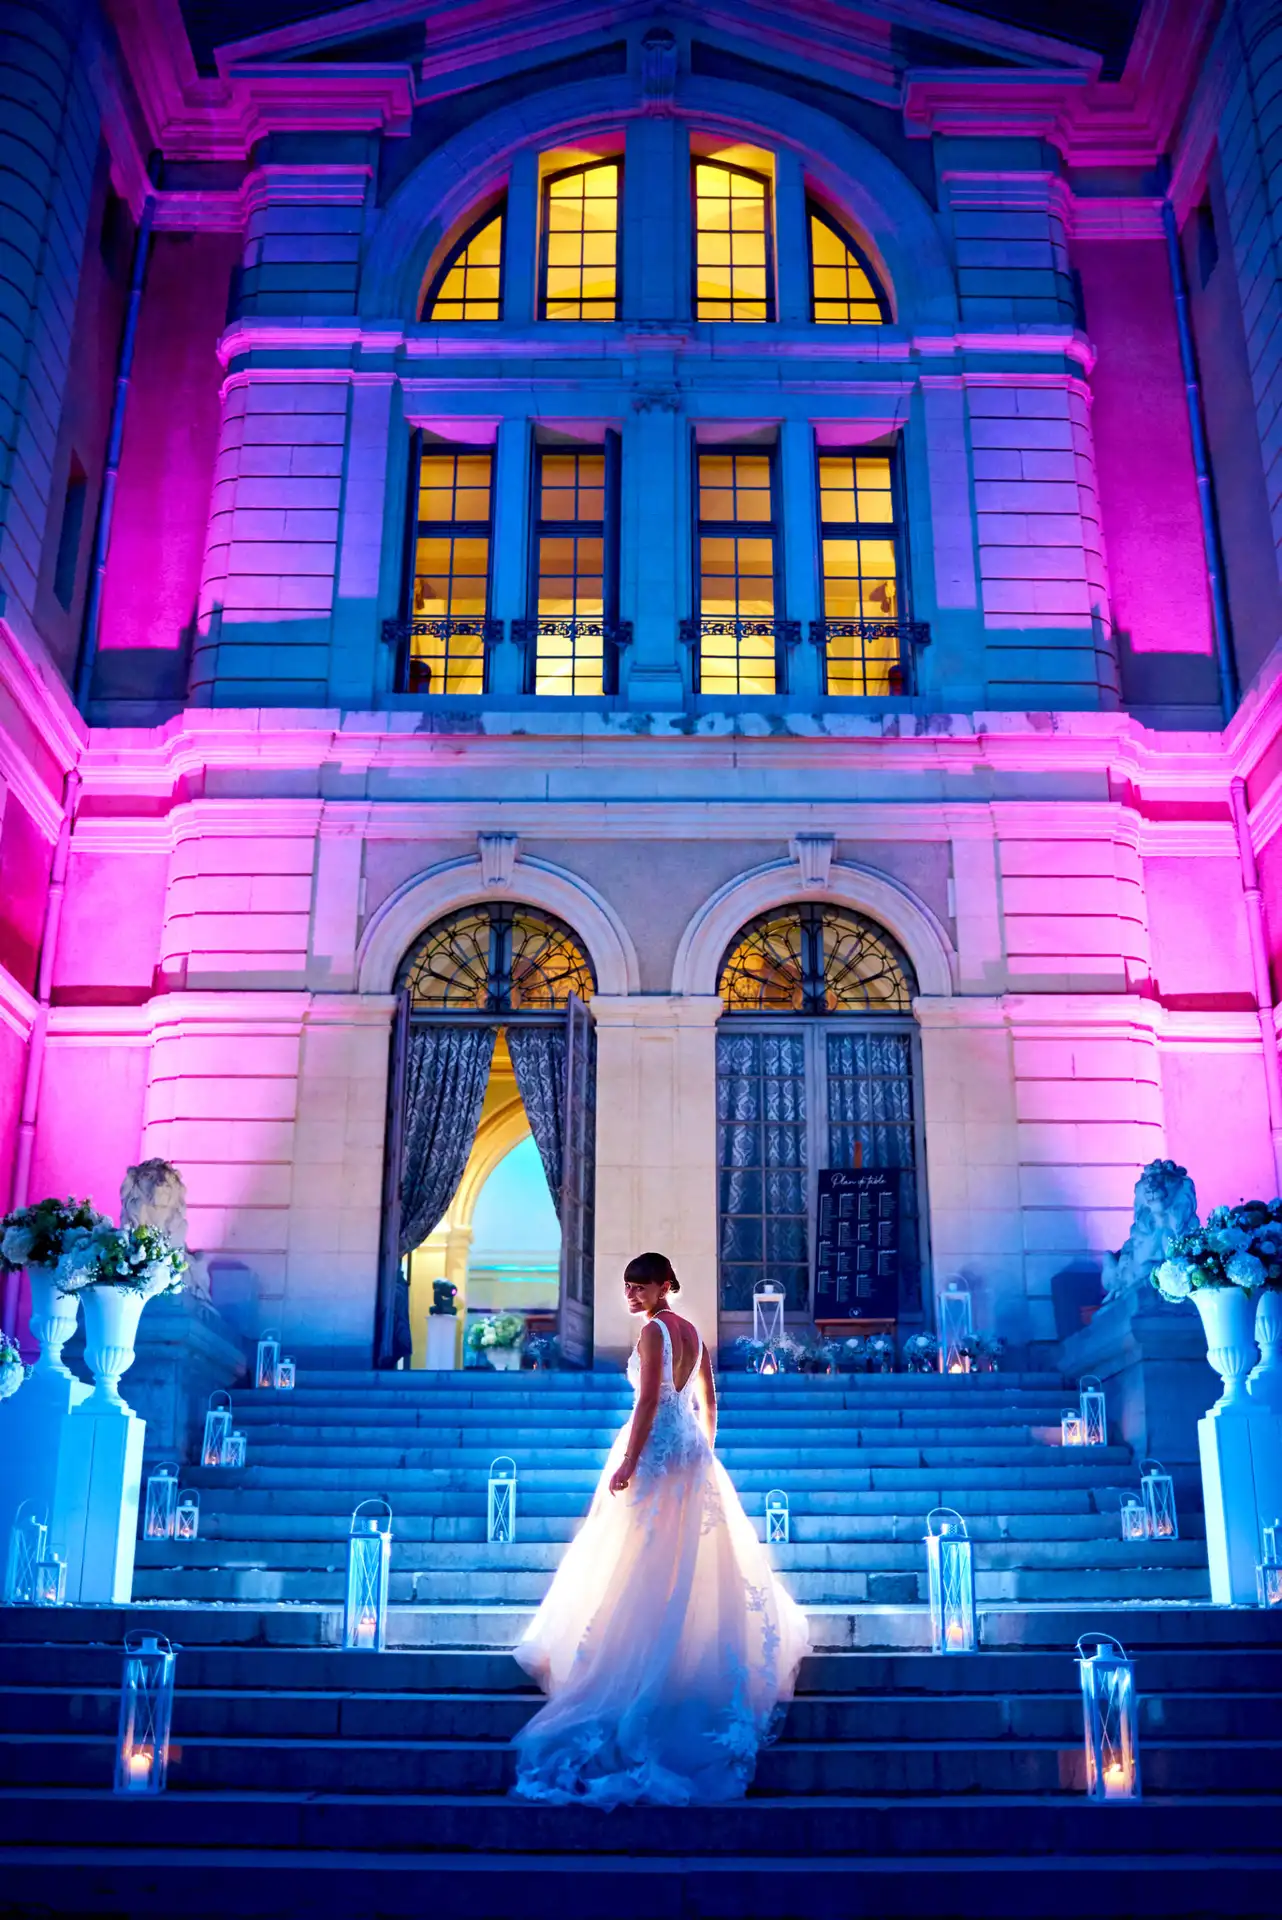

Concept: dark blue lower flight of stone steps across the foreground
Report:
left=0, top=1605, right=1282, bottom=1920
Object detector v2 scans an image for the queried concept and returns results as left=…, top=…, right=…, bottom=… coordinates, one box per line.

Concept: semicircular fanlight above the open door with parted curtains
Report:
left=397, top=900, right=597, bottom=1014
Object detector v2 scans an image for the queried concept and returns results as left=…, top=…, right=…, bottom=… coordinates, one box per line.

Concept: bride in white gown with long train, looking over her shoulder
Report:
left=514, top=1254, right=808, bottom=1807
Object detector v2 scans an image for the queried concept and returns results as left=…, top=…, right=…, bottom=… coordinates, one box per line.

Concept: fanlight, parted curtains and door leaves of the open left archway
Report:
left=376, top=900, right=595, bottom=1367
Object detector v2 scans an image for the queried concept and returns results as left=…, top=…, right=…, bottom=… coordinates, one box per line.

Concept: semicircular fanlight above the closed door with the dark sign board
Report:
left=718, top=900, right=917, bottom=1016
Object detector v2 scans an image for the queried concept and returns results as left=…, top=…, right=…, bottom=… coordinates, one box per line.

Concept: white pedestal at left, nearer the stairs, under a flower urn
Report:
left=54, top=1407, right=148, bottom=1605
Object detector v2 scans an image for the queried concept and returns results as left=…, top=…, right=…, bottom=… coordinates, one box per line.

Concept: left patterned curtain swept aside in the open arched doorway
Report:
left=401, top=1027, right=495, bottom=1254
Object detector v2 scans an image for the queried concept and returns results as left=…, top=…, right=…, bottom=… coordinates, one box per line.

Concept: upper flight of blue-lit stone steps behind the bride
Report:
left=134, top=1371, right=1209, bottom=1612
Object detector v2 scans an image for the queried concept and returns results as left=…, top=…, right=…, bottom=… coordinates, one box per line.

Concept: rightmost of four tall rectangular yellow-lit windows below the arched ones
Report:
left=819, top=453, right=900, bottom=695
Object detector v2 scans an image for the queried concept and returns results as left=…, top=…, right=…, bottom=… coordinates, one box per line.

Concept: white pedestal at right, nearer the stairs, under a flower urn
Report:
left=1198, top=1407, right=1282, bottom=1607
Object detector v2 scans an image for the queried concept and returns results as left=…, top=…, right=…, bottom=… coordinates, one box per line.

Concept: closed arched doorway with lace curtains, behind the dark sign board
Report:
left=716, top=900, right=925, bottom=1331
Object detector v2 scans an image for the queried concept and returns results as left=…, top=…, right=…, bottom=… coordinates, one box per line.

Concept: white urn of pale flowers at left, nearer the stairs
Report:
left=58, top=1221, right=188, bottom=1413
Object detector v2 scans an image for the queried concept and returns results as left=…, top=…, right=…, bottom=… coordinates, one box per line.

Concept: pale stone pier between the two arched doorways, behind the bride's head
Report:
left=591, top=995, right=722, bottom=1367
